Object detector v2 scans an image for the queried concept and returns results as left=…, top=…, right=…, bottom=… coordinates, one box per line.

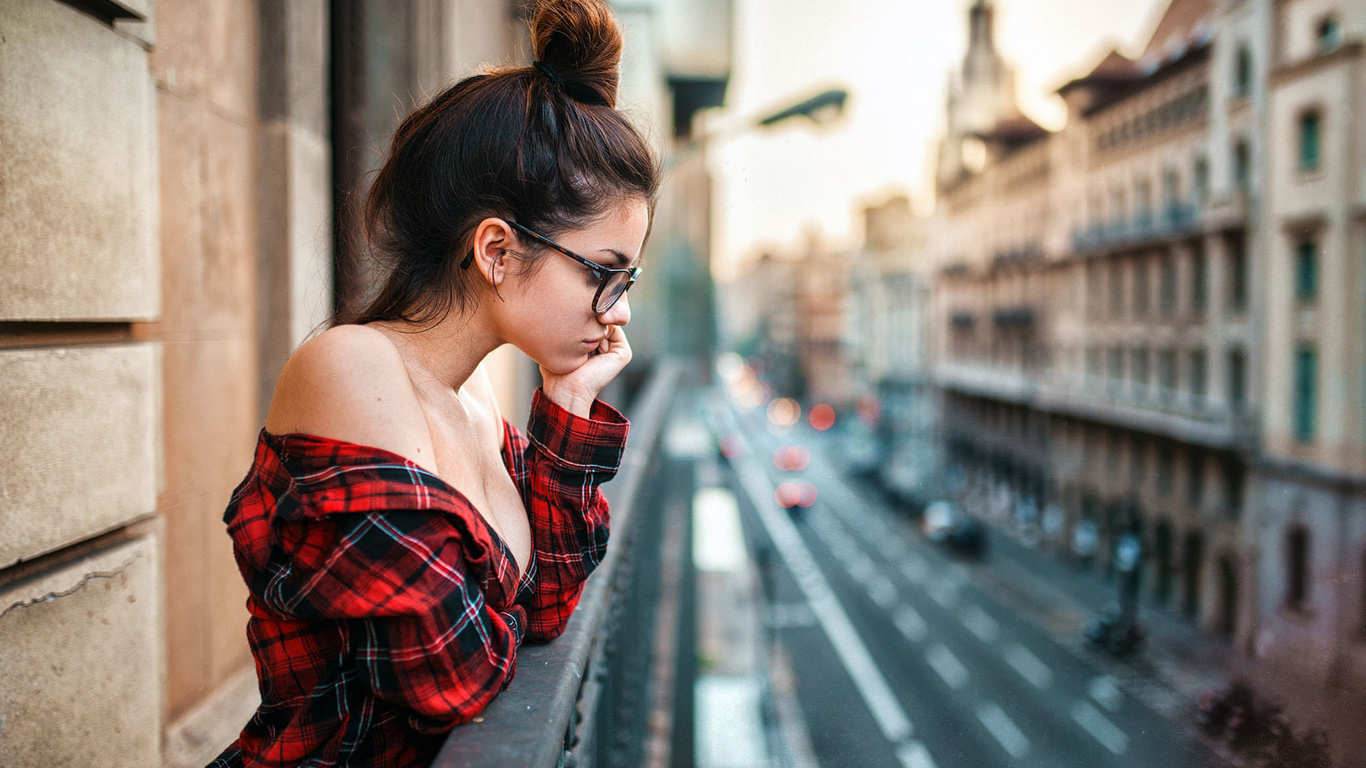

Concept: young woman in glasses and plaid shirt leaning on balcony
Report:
left=213, top=0, right=658, bottom=768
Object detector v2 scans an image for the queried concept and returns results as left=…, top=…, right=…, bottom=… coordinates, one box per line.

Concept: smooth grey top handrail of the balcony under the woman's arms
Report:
left=432, top=359, right=682, bottom=768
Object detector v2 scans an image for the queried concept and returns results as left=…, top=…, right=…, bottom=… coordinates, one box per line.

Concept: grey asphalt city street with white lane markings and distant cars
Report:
left=712, top=400, right=1216, bottom=768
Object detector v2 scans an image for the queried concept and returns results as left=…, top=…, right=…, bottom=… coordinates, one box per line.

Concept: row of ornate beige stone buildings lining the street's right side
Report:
left=933, top=0, right=1366, bottom=687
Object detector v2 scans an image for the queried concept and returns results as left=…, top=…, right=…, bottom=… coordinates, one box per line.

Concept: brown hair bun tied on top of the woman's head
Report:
left=531, top=0, right=622, bottom=108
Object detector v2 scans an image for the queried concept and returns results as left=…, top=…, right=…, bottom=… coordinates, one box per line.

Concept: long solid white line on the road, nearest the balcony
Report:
left=736, top=437, right=911, bottom=743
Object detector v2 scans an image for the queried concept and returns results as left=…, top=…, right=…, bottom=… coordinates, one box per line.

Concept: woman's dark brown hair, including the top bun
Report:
left=333, top=0, right=660, bottom=324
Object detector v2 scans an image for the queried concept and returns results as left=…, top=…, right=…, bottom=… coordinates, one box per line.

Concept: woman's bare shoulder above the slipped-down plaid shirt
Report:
left=265, top=325, right=433, bottom=469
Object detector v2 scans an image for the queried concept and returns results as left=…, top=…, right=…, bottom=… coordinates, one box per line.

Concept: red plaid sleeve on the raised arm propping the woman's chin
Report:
left=504, top=389, right=630, bottom=641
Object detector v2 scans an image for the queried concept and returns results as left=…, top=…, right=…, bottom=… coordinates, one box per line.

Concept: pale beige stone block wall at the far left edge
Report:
left=0, top=0, right=165, bottom=768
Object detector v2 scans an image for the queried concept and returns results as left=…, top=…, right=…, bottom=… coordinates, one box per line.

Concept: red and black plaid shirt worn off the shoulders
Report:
left=210, top=391, right=630, bottom=768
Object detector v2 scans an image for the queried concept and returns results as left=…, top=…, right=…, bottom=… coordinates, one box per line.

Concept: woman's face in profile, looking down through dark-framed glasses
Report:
left=494, top=198, right=650, bottom=373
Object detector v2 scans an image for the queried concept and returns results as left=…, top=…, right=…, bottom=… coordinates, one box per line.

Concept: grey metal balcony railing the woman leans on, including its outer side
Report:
left=433, top=361, right=682, bottom=768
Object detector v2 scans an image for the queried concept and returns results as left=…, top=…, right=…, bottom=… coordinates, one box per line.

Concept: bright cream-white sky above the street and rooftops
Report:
left=712, top=0, right=1168, bottom=279
